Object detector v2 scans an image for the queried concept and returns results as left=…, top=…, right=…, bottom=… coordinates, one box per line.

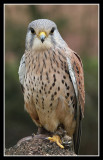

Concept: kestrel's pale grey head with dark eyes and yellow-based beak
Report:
left=26, top=19, right=63, bottom=51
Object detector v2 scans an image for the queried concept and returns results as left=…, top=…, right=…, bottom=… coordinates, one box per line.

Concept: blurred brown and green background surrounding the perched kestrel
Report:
left=5, top=5, right=98, bottom=155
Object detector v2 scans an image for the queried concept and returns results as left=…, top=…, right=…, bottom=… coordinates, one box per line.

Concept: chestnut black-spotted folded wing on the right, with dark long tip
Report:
left=67, top=52, right=85, bottom=154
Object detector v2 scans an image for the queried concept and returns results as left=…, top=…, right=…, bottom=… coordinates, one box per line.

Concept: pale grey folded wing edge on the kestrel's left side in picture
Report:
left=18, top=54, right=25, bottom=93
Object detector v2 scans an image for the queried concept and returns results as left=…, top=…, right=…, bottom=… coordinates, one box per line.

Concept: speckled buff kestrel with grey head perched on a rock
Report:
left=18, top=19, right=85, bottom=154
